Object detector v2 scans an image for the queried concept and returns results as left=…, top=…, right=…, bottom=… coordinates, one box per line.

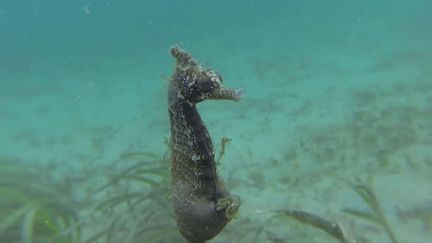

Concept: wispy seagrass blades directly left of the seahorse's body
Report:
left=84, top=152, right=180, bottom=243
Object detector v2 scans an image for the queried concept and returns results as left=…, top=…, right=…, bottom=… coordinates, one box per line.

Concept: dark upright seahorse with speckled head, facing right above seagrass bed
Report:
left=168, top=46, right=243, bottom=243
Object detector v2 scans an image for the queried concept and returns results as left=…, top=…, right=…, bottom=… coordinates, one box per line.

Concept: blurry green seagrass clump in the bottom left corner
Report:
left=0, top=158, right=81, bottom=243
